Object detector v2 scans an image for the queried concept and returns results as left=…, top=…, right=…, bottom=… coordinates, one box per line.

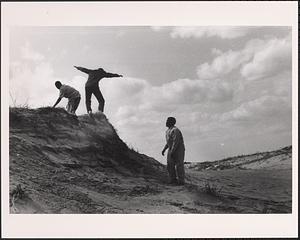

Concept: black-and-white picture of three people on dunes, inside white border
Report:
left=1, top=3, right=298, bottom=238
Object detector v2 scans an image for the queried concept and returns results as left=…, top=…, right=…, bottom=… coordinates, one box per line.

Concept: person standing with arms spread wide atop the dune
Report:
left=74, top=66, right=123, bottom=114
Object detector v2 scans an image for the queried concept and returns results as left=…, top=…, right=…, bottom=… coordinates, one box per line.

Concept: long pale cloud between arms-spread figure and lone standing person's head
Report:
left=100, top=75, right=233, bottom=123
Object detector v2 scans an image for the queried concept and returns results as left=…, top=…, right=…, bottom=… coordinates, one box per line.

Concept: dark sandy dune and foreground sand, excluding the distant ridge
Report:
left=9, top=108, right=291, bottom=214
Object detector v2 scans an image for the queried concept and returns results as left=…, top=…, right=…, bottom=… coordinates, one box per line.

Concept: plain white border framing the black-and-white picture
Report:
left=1, top=1, right=298, bottom=238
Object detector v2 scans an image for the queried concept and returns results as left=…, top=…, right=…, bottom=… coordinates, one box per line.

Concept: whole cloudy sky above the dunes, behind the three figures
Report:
left=9, top=26, right=292, bottom=163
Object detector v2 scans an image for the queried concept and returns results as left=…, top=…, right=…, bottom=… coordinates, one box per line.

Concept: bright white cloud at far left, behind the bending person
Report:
left=9, top=42, right=70, bottom=108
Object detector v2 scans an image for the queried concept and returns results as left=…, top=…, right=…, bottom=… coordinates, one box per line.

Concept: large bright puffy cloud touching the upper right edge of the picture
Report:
left=197, top=33, right=291, bottom=80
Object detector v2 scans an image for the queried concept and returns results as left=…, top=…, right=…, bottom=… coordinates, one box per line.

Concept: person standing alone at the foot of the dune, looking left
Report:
left=162, top=117, right=185, bottom=185
